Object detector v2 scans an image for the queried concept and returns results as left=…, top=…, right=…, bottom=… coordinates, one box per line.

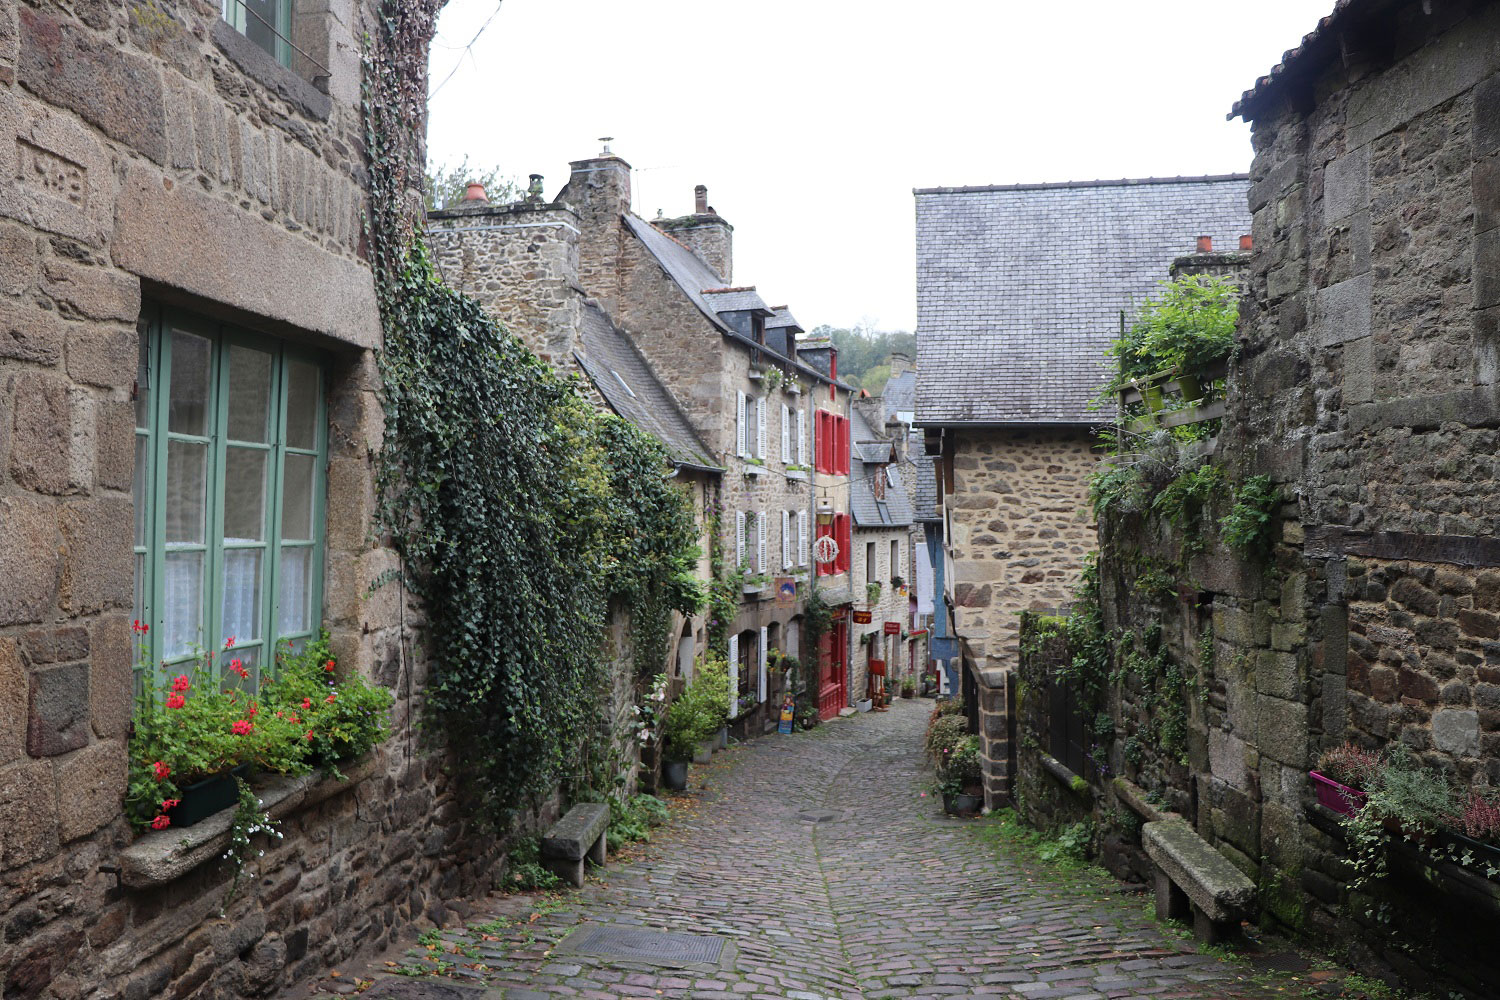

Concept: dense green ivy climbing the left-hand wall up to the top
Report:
left=365, top=0, right=701, bottom=825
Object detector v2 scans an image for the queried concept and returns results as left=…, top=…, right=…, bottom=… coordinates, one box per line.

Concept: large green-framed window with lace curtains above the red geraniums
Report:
left=135, top=307, right=329, bottom=690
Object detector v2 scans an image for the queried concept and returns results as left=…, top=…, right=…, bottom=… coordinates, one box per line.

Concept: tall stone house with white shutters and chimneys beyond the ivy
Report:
left=429, top=150, right=849, bottom=735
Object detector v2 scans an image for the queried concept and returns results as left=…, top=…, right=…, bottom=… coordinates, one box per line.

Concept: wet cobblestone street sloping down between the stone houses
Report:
left=318, top=702, right=1329, bottom=1000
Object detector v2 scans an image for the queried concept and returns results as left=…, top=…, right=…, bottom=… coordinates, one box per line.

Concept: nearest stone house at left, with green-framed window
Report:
left=0, top=0, right=495, bottom=999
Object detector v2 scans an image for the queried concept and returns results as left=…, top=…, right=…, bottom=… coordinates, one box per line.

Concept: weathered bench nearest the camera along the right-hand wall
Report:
left=1140, top=817, right=1256, bottom=945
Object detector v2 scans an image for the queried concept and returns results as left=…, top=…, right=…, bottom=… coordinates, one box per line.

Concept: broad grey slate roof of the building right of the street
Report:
left=915, top=174, right=1250, bottom=424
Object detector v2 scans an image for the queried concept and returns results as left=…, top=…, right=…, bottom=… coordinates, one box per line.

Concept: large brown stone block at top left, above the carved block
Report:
left=17, top=7, right=167, bottom=163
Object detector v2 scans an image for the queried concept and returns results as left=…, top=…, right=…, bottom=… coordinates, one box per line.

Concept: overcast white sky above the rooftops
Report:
left=428, top=0, right=1334, bottom=330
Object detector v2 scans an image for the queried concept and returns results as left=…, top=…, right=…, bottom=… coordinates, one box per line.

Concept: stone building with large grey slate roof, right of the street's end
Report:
left=915, top=175, right=1250, bottom=804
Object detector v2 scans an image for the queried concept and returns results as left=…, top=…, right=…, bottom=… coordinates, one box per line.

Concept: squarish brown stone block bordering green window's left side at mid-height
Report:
left=62, top=498, right=135, bottom=615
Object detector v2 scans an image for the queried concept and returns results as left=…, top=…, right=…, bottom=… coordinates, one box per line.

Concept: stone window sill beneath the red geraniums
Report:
left=120, top=751, right=381, bottom=889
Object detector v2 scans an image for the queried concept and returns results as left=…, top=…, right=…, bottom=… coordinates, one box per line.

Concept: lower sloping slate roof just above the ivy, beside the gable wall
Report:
left=573, top=303, right=719, bottom=471
